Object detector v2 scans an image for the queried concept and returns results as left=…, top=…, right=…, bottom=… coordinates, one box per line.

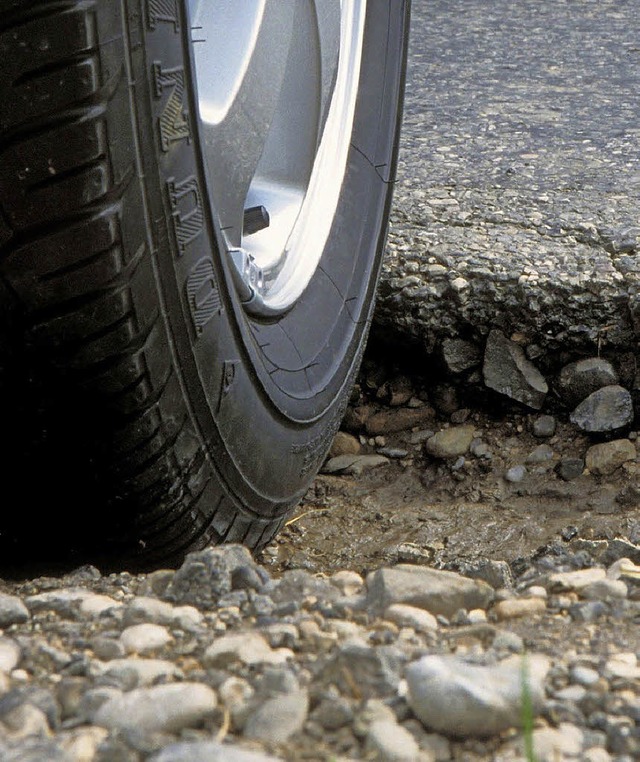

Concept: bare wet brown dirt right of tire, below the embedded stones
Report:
left=261, top=350, right=640, bottom=573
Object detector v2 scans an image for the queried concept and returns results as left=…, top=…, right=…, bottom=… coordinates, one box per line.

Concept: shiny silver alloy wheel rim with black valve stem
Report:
left=189, top=0, right=367, bottom=314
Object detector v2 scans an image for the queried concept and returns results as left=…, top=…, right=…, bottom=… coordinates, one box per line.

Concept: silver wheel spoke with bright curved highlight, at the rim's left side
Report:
left=192, top=0, right=295, bottom=245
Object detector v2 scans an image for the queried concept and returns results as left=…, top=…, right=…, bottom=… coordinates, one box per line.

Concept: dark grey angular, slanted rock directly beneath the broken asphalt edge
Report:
left=482, top=329, right=549, bottom=410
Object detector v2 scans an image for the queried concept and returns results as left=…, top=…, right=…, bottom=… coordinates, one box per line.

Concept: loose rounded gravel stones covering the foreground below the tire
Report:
left=0, top=537, right=640, bottom=762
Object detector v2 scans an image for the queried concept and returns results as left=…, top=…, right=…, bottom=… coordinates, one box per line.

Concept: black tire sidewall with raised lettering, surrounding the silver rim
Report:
left=135, top=0, right=408, bottom=517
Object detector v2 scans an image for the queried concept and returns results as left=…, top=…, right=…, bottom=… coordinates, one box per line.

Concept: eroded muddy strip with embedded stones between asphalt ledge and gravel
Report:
left=263, top=346, right=640, bottom=573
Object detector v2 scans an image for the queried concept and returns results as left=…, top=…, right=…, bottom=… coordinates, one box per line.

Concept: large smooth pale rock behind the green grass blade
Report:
left=406, top=655, right=549, bottom=737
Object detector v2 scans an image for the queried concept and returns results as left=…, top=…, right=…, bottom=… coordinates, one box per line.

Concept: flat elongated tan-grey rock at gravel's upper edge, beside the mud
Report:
left=367, top=564, right=493, bottom=617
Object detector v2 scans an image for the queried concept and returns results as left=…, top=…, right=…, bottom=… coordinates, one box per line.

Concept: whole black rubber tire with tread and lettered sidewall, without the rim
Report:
left=0, top=0, right=409, bottom=564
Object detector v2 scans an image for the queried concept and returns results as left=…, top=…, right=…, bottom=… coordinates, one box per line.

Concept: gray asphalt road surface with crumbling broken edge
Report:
left=376, top=0, right=640, bottom=360
